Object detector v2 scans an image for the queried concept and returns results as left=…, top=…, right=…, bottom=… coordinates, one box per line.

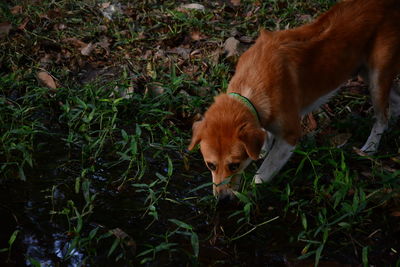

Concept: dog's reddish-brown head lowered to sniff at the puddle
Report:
left=188, top=94, right=266, bottom=199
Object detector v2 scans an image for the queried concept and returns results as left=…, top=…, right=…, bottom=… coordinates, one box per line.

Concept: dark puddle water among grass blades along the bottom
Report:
left=0, top=141, right=400, bottom=267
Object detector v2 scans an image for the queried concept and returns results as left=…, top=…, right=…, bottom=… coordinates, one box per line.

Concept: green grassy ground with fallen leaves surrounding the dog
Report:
left=0, top=0, right=400, bottom=266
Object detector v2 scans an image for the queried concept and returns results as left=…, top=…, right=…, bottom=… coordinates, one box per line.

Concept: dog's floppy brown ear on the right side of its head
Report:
left=238, top=123, right=267, bottom=160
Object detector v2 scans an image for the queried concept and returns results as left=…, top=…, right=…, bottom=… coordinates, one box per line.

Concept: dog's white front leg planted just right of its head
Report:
left=254, top=137, right=295, bottom=184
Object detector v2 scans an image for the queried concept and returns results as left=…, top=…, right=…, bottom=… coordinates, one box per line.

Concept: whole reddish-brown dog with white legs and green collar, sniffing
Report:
left=189, top=0, right=400, bottom=201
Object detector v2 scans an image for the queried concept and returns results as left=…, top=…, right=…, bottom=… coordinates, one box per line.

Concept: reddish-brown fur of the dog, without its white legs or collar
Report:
left=189, top=0, right=400, bottom=199
